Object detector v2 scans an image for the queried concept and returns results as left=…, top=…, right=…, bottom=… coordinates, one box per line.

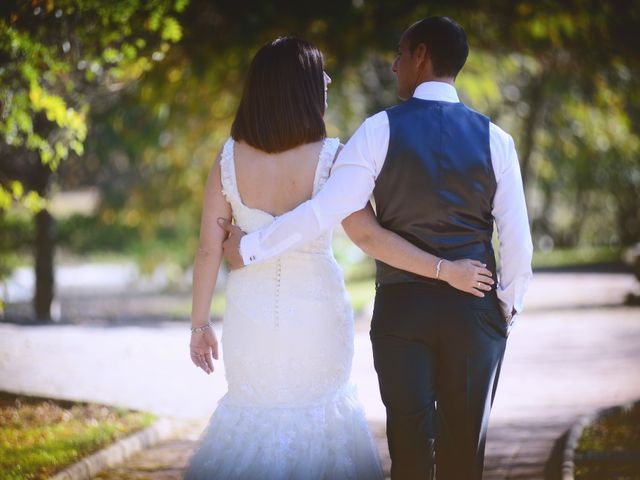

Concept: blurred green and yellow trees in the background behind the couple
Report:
left=3, top=0, right=640, bottom=282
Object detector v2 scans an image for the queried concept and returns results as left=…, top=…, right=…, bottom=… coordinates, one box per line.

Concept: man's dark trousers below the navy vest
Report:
left=370, top=283, right=508, bottom=480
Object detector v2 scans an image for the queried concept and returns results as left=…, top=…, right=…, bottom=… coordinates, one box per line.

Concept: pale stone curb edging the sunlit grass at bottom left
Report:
left=49, top=417, right=187, bottom=480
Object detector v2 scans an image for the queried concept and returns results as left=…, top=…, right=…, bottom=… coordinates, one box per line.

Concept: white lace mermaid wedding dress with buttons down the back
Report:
left=184, top=138, right=383, bottom=480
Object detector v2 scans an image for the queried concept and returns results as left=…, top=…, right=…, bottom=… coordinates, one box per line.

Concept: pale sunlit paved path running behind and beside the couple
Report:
left=0, top=273, right=640, bottom=480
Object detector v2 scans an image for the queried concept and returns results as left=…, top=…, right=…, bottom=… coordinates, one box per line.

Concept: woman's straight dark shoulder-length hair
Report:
left=231, top=37, right=327, bottom=153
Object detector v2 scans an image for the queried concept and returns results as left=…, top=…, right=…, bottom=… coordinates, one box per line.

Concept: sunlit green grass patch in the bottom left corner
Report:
left=0, top=392, right=156, bottom=480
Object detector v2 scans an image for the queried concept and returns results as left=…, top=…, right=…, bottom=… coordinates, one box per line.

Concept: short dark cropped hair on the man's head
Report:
left=405, top=17, right=469, bottom=78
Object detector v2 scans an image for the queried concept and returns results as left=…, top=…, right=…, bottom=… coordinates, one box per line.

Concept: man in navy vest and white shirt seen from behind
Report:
left=224, top=17, right=533, bottom=480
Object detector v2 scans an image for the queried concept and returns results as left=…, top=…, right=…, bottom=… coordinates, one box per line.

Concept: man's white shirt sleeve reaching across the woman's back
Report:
left=240, top=112, right=389, bottom=265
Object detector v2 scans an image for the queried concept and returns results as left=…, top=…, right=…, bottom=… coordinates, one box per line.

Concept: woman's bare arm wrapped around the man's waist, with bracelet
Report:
left=342, top=203, right=494, bottom=297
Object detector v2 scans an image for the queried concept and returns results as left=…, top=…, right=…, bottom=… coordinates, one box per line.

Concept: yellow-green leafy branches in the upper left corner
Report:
left=0, top=0, right=186, bottom=212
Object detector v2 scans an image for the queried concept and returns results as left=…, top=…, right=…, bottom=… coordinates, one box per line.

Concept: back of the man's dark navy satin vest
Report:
left=373, top=97, right=496, bottom=285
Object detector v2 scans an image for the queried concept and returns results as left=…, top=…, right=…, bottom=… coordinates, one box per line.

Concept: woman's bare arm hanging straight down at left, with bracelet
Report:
left=191, top=148, right=231, bottom=373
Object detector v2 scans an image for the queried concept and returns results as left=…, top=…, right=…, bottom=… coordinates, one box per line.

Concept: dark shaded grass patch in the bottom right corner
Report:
left=575, top=402, right=640, bottom=480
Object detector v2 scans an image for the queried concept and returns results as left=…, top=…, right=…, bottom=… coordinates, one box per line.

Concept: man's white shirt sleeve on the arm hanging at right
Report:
left=491, top=124, right=533, bottom=317
